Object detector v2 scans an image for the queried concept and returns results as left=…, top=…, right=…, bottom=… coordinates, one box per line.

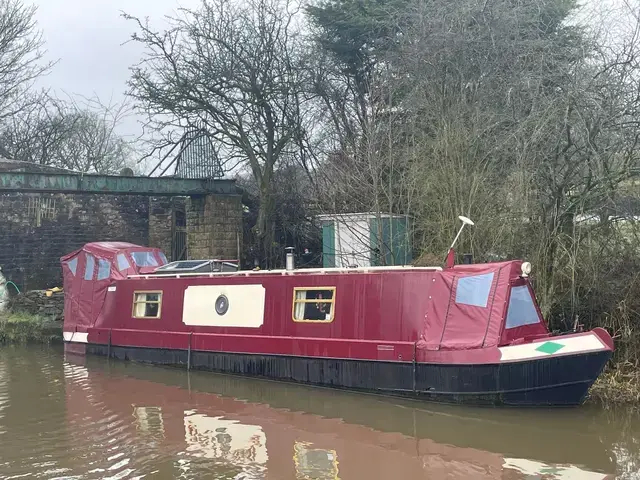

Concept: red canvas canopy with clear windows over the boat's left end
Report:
left=60, top=242, right=167, bottom=332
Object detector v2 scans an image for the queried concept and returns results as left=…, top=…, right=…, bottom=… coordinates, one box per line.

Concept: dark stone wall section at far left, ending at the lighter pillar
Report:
left=0, top=193, right=149, bottom=290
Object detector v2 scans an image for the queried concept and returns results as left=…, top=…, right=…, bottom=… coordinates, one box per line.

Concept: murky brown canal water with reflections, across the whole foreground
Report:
left=0, top=347, right=640, bottom=480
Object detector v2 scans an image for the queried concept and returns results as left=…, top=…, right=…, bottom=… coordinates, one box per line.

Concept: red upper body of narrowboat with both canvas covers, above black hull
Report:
left=62, top=242, right=549, bottom=362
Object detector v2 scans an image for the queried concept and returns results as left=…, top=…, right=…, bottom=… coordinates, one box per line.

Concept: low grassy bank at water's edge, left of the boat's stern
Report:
left=0, top=312, right=62, bottom=344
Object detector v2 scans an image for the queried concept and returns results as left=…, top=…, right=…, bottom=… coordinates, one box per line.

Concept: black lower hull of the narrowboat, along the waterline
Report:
left=81, top=344, right=611, bottom=406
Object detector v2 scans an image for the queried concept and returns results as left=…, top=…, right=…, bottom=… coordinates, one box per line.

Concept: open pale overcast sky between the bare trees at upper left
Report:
left=27, top=0, right=200, bottom=142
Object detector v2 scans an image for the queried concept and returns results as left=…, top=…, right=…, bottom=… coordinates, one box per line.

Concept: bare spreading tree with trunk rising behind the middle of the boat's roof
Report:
left=127, top=0, right=308, bottom=265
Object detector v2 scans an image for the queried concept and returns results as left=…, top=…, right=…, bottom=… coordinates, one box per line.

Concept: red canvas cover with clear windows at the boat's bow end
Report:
left=419, top=261, right=547, bottom=350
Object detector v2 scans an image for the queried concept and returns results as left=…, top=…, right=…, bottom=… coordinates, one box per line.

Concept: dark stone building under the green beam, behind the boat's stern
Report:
left=0, top=160, right=242, bottom=289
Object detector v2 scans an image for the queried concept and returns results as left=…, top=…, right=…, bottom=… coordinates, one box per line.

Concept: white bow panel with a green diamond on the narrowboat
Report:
left=499, top=333, right=607, bottom=362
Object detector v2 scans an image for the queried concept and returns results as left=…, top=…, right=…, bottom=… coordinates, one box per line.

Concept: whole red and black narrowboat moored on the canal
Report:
left=61, top=217, right=614, bottom=406
